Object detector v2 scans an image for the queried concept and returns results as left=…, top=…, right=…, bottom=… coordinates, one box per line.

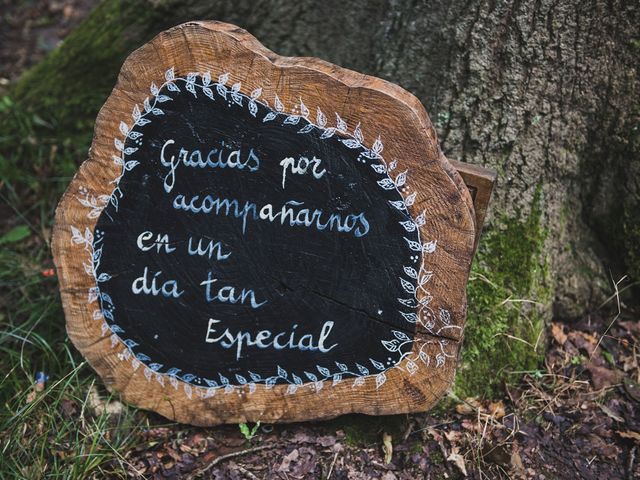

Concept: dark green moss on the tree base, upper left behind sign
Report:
left=10, top=0, right=179, bottom=142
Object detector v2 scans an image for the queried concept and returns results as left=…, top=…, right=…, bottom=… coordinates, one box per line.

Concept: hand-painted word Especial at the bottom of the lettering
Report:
left=205, top=318, right=338, bottom=360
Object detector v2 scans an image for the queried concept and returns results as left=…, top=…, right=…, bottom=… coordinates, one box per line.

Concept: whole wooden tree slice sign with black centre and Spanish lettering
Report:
left=53, top=22, right=476, bottom=425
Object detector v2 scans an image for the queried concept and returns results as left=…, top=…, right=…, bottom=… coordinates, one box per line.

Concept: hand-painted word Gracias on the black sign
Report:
left=160, top=139, right=260, bottom=193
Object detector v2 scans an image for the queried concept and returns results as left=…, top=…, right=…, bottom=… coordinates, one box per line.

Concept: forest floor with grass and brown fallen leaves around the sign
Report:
left=0, top=1, right=640, bottom=480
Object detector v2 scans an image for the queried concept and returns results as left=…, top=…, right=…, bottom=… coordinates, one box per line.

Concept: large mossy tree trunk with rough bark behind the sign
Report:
left=14, top=0, right=640, bottom=395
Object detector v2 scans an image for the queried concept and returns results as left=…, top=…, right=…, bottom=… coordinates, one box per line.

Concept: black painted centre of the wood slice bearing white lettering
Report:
left=94, top=76, right=421, bottom=386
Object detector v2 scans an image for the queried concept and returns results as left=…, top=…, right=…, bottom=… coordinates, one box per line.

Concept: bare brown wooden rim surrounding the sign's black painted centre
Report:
left=52, top=22, right=476, bottom=425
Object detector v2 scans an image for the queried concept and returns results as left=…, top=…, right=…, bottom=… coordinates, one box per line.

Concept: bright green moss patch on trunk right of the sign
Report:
left=455, top=188, right=549, bottom=398
